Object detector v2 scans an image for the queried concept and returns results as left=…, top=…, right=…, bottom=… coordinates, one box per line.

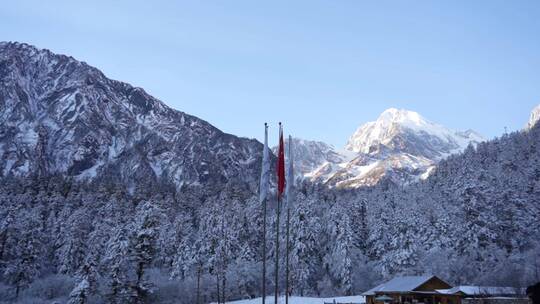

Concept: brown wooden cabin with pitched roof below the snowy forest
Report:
left=362, top=275, right=461, bottom=304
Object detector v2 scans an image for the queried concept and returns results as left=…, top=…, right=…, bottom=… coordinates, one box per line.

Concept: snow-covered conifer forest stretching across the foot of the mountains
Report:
left=0, top=120, right=540, bottom=303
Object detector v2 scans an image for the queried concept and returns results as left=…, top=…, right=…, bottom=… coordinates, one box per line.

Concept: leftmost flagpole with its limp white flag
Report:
left=259, top=123, right=270, bottom=304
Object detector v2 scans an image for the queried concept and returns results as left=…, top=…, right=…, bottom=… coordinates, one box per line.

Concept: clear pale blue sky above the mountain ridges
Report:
left=0, top=0, right=540, bottom=147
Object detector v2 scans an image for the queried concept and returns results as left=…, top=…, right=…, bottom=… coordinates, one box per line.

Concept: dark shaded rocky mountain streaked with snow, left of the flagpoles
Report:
left=0, top=42, right=262, bottom=191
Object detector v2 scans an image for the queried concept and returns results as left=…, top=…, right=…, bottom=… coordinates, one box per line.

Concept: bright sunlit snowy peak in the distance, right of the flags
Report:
left=302, top=108, right=484, bottom=187
